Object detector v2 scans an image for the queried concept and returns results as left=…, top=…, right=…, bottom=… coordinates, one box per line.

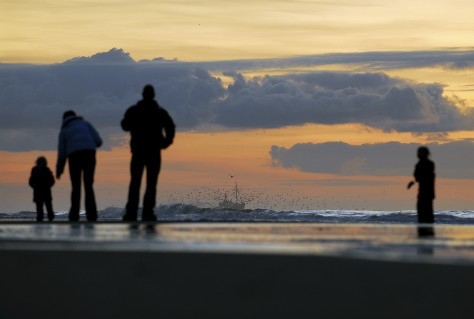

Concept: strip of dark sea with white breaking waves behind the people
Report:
left=0, top=204, right=474, bottom=225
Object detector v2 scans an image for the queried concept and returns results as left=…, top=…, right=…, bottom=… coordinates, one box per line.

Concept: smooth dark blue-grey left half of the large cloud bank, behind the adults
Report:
left=0, top=49, right=224, bottom=151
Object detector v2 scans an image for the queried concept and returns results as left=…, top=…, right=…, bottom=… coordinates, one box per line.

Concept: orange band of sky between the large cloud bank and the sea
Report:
left=0, top=125, right=474, bottom=211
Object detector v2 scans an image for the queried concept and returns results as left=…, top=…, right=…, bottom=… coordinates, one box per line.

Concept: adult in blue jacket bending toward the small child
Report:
left=56, top=111, right=102, bottom=221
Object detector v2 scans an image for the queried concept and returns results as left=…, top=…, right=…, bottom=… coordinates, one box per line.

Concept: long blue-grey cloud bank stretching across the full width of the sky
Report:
left=0, top=49, right=474, bottom=151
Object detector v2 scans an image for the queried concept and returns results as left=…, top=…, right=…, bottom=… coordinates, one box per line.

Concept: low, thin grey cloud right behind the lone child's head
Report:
left=270, top=140, right=474, bottom=179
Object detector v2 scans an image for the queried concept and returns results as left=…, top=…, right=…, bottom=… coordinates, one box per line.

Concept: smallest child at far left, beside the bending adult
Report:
left=28, top=156, right=54, bottom=222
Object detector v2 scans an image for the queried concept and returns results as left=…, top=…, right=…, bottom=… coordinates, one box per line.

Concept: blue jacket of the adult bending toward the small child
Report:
left=56, top=116, right=102, bottom=176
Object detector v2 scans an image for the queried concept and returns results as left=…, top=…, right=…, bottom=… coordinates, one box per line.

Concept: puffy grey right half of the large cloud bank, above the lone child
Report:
left=216, top=72, right=474, bottom=132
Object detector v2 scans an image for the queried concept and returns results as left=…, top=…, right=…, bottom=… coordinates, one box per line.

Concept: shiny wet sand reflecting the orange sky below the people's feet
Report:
left=0, top=222, right=474, bottom=264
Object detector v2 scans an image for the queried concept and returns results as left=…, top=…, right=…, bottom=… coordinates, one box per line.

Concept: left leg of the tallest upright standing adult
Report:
left=123, top=155, right=145, bottom=221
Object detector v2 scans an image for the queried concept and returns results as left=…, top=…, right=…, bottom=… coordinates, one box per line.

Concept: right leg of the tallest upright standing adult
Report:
left=142, top=154, right=161, bottom=221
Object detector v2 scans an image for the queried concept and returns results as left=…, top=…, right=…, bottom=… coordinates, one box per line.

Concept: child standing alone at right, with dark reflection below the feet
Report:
left=407, top=146, right=435, bottom=237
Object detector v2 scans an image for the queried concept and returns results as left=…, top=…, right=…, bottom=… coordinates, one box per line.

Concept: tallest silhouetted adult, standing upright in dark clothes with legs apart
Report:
left=121, top=85, right=175, bottom=221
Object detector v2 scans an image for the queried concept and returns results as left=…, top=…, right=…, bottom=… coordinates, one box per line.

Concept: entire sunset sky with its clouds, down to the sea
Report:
left=0, top=0, right=474, bottom=212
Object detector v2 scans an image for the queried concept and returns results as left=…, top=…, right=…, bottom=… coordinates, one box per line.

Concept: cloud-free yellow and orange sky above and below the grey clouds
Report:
left=0, top=0, right=474, bottom=212
